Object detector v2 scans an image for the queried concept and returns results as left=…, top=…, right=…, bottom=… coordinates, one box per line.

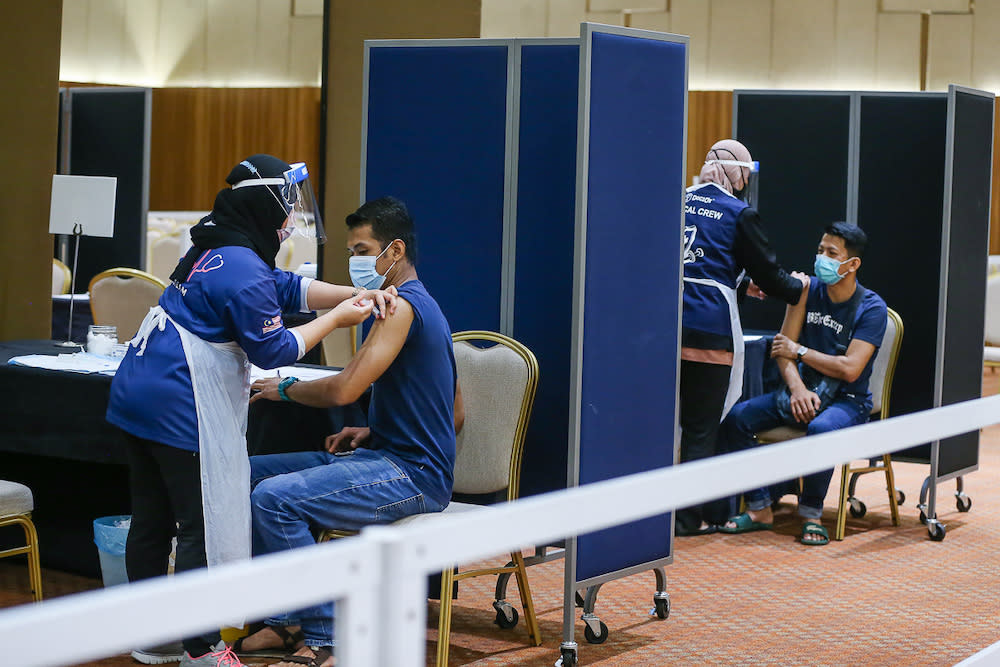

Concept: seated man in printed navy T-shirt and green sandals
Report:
left=719, top=222, right=887, bottom=545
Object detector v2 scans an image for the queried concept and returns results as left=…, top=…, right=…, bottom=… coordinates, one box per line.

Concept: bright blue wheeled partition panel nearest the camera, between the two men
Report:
left=564, top=24, right=687, bottom=596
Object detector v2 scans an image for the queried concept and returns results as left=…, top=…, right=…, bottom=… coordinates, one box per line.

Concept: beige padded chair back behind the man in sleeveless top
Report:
left=451, top=331, right=538, bottom=500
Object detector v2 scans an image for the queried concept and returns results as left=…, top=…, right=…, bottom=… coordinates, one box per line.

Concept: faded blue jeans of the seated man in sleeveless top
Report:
left=250, top=449, right=444, bottom=646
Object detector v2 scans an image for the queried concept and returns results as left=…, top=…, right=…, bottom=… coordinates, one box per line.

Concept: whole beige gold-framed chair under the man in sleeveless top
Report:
left=321, top=331, right=542, bottom=667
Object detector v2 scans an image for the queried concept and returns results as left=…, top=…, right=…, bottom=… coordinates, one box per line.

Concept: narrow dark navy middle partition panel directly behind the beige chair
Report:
left=513, top=39, right=580, bottom=496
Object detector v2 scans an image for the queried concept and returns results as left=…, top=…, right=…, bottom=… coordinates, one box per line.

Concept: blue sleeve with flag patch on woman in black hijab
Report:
left=225, top=281, right=299, bottom=368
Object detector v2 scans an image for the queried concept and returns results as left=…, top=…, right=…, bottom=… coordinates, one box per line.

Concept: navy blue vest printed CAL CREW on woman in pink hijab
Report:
left=683, top=183, right=747, bottom=337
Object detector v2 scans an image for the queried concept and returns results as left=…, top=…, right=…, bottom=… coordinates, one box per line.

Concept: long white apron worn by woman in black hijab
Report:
left=131, top=306, right=250, bottom=567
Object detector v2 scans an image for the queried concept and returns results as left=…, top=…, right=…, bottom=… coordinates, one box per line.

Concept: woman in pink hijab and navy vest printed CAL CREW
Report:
left=675, top=139, right=809, bottom=536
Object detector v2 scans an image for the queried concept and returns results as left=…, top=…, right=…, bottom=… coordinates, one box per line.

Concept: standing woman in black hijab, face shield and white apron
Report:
left=107, top=155, right=395, bottom=667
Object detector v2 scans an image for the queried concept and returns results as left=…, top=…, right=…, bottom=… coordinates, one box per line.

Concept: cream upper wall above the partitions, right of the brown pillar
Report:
left=482, top=0, right=1000, bottom=93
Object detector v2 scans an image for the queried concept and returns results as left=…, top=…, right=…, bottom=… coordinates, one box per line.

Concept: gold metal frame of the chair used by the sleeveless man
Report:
left=319, top=331, right=542, bottom=667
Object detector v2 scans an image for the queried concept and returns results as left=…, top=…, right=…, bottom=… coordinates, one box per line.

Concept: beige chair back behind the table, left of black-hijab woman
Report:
left=89, top=268, right=167, bottom=342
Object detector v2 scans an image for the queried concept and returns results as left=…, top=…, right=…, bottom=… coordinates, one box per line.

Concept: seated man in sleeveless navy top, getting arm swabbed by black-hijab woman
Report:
left=242, top=197, right=464, bottom=667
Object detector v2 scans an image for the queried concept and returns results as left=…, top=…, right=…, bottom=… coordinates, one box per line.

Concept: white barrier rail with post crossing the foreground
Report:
left=0, top=396, right=1000, bottom=667
